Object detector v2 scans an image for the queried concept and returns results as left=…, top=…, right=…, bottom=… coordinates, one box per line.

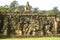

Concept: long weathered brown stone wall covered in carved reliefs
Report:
left=0, top=12, right=60, bottom=36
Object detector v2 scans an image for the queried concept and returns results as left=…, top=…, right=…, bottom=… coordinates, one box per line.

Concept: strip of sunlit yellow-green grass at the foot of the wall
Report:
left=0, top=37, right=60, bottom=40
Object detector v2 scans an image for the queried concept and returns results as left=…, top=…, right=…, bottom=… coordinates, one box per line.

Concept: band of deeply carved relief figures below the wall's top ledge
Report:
left=0, top=15, right=57, bottom=35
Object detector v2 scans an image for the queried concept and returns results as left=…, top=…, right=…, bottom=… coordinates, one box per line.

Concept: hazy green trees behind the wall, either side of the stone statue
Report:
left=0, top=0, right=60, bottom=14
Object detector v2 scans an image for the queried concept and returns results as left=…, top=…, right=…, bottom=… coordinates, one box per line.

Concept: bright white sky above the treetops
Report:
left=0, top=0, right=60, bottom=10
